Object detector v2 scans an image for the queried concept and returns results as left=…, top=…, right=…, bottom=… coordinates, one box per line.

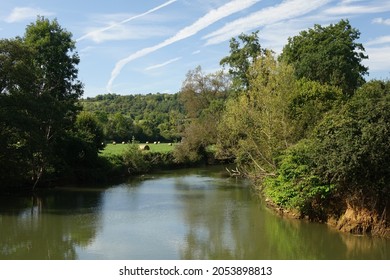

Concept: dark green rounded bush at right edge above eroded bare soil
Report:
left=314, top=81, right=390, bottom=208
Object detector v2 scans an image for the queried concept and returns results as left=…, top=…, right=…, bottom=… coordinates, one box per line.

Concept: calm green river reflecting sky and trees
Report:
left=0, top=167, right=390, bottom=260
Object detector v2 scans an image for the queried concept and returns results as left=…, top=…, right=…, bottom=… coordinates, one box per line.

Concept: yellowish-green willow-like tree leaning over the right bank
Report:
left=218, top=51, right=297, bottom=177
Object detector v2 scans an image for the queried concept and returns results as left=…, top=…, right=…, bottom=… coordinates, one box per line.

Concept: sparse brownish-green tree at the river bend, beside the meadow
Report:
left=175, top=67, right=230, bottom=162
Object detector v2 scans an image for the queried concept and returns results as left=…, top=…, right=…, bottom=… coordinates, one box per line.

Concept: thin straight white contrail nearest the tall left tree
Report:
left=77, top=0, right=177, bottom=42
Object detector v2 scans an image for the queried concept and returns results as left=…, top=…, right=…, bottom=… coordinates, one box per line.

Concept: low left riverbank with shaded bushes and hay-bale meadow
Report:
left=0, top=143, right=227, bottom=195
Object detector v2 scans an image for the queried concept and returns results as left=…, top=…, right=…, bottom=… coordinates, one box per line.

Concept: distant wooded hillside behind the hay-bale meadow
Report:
left=80, top=93, right=185, bottom=142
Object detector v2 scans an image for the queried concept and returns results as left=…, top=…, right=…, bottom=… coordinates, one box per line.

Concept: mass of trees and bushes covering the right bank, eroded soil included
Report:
left=213, top=20, right=390, bottom=236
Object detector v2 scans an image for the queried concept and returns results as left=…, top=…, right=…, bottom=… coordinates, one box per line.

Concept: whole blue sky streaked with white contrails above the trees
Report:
left=0, top=0, right=390, bottom=97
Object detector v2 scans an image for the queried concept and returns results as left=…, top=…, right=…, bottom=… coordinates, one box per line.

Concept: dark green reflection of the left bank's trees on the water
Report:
left=0, top=191, right=101, bottom=260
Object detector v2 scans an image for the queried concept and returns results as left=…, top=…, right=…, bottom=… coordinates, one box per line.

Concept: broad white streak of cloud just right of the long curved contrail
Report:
left=203, top=0, right=330, bottom=45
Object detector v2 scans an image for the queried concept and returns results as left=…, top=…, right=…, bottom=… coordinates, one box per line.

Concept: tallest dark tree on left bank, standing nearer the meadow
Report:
left=23, top=17, right=83, bottom=188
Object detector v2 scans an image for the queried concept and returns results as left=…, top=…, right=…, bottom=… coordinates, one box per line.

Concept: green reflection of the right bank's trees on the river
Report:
left=171, top=167, right=390, bottom=260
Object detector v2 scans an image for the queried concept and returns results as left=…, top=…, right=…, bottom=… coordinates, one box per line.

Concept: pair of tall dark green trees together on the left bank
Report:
left=0, top=17, right=83, bottom=186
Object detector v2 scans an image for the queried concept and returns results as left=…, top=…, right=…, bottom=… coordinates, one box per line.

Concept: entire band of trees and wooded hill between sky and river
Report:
left=0, top=17, right=390, bottom=236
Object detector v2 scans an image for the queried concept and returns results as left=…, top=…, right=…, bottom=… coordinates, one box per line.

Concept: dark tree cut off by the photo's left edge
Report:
left=0, top=38, right=34, bottom=187
